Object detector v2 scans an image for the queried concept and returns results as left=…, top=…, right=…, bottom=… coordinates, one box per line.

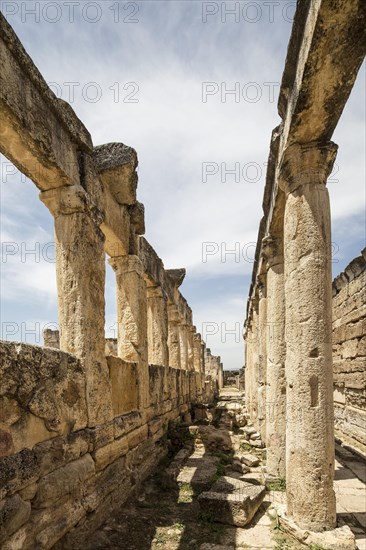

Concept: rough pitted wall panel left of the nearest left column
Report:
left=0, top=342, right=87, bottom=462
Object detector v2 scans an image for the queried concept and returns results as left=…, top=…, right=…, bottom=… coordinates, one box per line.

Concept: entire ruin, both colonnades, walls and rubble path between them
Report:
left=0, top=0, right=366, bottom=550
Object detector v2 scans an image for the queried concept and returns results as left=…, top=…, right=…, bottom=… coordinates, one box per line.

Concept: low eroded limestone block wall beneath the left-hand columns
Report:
left=0, top=342, right=213, bottom=550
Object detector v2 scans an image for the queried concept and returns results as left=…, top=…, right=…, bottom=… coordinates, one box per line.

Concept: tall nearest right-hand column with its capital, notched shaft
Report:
left=279, top=142, right=337, bottom=531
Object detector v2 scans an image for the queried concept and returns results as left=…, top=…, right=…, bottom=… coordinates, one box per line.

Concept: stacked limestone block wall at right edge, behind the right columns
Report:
left=333, top=248, right=366, bottom=458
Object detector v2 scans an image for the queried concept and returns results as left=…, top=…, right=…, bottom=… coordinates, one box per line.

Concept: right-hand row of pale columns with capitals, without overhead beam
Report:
left=245, top=142, right=337, bottom=531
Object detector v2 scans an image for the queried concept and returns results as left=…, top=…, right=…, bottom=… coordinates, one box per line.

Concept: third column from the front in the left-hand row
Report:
left=146, top=286, right=169, bottom=366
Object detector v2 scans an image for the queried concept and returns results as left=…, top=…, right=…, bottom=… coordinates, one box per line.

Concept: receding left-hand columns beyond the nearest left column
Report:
left=109, top=255, right=206, bottom=407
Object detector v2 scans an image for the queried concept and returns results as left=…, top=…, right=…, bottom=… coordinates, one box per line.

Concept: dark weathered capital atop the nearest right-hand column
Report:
left=278, top=141, right=338, bottom=194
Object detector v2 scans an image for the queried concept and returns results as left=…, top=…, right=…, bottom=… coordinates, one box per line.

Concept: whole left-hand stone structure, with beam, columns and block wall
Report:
left=0, top=10, right=222, bottom=550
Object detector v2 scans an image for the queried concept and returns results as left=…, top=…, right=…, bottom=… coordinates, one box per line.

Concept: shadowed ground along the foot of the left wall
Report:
left=75, top=390, right=275, bottom=550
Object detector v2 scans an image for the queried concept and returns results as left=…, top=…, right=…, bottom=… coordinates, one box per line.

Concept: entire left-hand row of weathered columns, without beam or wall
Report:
left=40, top=185, right=204, bottom=426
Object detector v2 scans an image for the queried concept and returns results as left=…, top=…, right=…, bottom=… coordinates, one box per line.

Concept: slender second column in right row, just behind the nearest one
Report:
left=263, top=237, right=286, bottom=478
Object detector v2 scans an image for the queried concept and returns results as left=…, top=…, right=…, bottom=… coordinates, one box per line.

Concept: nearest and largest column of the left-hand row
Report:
left=40, top=185, right=112, bottom=426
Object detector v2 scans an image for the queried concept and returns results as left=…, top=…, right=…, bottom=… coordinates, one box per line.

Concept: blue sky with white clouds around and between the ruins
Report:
left=1, top=0, right=366, bottom=368
